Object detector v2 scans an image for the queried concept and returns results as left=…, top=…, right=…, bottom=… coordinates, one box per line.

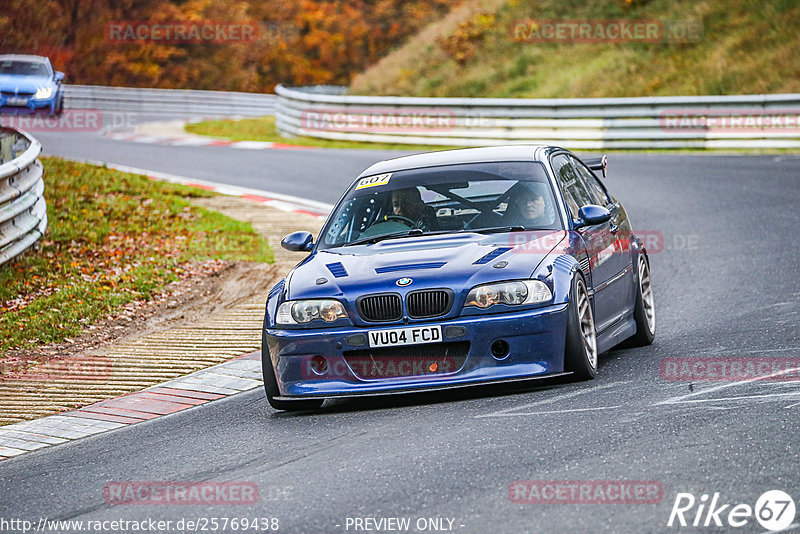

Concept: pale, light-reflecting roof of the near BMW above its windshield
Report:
left=359, top=145, right=560, bottom=178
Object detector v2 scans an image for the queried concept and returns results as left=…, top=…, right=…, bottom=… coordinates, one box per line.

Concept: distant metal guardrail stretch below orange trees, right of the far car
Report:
left=64, top=85, right=277, bottom=118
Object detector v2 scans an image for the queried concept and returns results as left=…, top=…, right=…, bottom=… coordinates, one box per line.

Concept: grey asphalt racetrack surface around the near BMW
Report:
left=0, top=134, right=800, bottom=533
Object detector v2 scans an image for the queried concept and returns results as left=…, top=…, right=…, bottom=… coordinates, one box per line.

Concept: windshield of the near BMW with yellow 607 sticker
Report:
left=319, top=161, right=562, bottom=249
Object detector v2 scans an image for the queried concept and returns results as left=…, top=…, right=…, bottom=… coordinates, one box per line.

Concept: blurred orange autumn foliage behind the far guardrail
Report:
left=0, top=0, right=459, bottom=92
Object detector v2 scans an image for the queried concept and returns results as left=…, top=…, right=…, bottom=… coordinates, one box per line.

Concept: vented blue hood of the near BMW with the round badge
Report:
left=287, top=230, right=566, bottom=299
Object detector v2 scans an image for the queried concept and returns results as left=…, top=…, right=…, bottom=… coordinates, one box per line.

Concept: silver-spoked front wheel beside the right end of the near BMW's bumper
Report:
left=564, top=275, right=597, bottom=380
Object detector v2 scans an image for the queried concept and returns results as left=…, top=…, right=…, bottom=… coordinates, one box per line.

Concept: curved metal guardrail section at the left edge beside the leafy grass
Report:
left=0, top=128, right=47, bottom=265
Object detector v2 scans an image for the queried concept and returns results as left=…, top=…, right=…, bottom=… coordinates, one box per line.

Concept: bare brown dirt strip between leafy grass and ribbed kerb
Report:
left=0, top=260, right=278, bottom=376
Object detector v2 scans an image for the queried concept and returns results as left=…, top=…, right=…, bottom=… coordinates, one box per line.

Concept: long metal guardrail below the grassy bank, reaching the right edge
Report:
left=275, top=85, right=800, bottom=150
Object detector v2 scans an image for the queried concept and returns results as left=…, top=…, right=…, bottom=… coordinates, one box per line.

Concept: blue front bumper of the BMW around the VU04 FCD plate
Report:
left=262, top=304, right=567, bottom=399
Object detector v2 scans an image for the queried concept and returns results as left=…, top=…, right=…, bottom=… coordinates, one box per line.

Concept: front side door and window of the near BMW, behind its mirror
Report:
left=551, top=154, right=619, bottom=332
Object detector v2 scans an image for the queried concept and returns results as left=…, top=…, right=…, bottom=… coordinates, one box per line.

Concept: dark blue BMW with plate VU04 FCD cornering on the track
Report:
left=262, top=145, right=655, bottom=410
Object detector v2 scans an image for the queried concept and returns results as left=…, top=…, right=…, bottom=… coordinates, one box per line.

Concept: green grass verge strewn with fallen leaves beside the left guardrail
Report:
left=0, top=158, right=273, bottom=357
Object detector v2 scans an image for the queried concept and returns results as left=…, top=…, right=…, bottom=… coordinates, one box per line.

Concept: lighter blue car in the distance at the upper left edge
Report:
left=0, top=54, right=64, bottom=115
